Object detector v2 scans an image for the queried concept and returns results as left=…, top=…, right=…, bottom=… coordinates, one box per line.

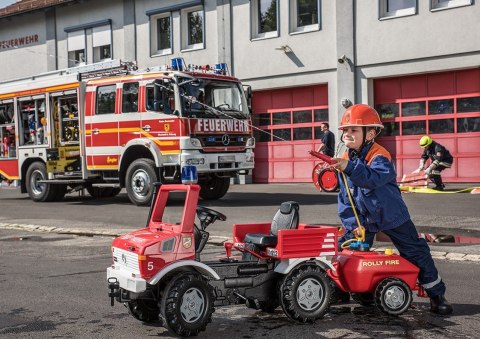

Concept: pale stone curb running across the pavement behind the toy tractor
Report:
left=0, top=223, right=480, bottom=262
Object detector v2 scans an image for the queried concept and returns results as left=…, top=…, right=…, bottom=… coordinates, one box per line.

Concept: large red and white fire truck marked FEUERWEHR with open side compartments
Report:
left=0, top=58, right=255, bottom=205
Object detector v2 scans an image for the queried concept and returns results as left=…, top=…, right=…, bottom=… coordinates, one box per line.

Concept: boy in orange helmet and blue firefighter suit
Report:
left=332, top=104, right=453, bottom=315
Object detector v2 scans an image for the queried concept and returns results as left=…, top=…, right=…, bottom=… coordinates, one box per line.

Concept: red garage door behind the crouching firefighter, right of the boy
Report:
left=374, top=68, right=480, bottom=182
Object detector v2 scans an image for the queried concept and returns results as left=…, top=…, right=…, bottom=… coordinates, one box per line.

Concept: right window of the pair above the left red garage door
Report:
left=290, top=0, right=320, bottom=32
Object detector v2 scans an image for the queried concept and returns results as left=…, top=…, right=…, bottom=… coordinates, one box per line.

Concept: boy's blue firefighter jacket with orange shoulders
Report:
left=338, top=143, right=410, bottom=232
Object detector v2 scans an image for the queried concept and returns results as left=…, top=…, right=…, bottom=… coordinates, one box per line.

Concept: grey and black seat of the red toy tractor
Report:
left=244, top=201, right=300, bottom=248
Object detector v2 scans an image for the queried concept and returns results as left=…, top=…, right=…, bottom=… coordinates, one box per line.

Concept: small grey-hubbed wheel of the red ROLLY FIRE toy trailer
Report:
left=375, top=278, right=412, bottom=315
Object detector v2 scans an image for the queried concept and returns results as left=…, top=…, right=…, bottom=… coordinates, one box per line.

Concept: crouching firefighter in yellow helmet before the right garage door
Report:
left=413, top=135, right=453, bottom=191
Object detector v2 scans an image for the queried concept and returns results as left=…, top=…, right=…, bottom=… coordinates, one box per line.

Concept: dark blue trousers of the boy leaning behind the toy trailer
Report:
left=339, top=220, right=446, bottom=298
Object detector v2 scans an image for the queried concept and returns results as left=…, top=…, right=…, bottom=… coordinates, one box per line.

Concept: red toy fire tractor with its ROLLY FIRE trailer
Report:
left=107, top=185, right=426, bottom=336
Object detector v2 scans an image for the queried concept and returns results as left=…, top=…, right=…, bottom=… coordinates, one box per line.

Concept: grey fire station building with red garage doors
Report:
left=0, top=0, right=480, bottom=183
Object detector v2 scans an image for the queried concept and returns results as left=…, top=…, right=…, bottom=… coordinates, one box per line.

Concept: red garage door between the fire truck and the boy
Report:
left=253, top=85, right=328, bottom=182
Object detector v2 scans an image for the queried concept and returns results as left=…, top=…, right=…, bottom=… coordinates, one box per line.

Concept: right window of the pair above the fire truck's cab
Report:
left=182, top=6, right=205, bottom=49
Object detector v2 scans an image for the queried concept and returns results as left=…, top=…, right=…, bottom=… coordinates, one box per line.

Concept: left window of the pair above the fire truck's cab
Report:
left=150, top=12, right=172, bottom=55
